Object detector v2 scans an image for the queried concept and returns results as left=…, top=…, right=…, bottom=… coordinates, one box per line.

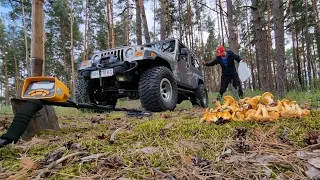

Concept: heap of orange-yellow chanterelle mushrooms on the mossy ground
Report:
left=201, top=92, right=310, bottom=122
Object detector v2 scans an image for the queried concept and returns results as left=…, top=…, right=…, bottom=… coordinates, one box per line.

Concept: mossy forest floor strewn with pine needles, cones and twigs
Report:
left=0, top=90, right=320, bottom=180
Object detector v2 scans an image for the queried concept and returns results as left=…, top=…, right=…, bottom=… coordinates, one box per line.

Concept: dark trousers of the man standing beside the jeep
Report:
left=219, top=74, right=243, bottom=98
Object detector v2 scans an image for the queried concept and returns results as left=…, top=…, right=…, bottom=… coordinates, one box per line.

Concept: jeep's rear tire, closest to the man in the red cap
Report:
left=190, top=84, right=208, bottom=108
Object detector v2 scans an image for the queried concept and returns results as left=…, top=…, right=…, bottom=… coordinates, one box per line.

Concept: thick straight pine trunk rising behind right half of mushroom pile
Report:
left=272, top=0, right=286, bottom=98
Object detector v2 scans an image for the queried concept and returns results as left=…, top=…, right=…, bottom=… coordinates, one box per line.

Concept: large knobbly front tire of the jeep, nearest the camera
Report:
left=139, top=66, right=178, bottom=112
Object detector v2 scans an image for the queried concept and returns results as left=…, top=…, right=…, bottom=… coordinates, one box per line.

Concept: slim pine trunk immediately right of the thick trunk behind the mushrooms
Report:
left=289, top=0, right=302, bottom=87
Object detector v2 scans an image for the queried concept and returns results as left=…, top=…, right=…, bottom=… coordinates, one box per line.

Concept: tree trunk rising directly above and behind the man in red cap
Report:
left=227, top=0, right=239, bottom=54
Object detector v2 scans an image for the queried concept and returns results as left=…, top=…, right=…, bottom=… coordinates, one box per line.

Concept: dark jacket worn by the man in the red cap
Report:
left=205, top=50, right=242, bottom=76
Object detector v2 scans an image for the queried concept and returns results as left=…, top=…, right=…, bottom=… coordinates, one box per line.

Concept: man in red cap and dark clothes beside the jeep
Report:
left=201, top=46, right=243, bottom=100
